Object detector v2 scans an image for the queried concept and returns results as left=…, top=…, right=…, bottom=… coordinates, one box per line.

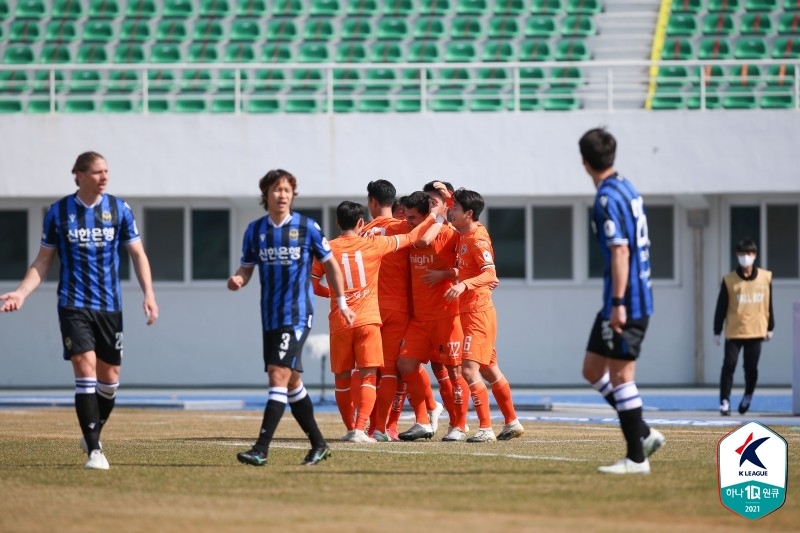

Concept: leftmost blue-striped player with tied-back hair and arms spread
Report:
left=0, top=152, right=158, bottom=470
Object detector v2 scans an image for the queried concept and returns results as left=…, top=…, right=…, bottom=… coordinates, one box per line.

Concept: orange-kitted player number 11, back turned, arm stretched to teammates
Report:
left=311, top=202, right=444, bottom=442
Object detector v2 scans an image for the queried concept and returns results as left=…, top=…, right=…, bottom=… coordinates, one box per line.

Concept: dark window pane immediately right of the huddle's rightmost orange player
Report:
left=488, top=207, right=525, bottom=279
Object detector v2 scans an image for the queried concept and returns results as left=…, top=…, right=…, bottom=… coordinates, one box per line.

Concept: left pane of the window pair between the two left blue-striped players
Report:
left=143, top=208, right=185, bottom=281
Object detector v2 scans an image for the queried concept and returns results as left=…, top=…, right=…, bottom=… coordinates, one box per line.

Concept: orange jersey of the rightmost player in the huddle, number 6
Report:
left=457, top=220, right=497, bottom=313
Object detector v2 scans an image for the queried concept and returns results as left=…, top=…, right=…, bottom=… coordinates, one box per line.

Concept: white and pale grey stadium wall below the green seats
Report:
left=0, top=111, right=800, bottom=387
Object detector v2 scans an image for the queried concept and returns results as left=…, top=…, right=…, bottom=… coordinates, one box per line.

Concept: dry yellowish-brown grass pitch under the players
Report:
left=0, top=408, right=800, bottom=532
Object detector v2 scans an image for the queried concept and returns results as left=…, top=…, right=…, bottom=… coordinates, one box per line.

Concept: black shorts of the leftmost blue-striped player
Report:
left=58, top=307, right=122, bottom=366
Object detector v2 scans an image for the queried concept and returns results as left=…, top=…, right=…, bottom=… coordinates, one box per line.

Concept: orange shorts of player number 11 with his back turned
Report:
left=331, top=324, right=383, bottom=374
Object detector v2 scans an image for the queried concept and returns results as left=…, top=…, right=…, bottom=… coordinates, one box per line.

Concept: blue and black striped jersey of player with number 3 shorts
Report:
left=241, top=213, right=332, bottom=331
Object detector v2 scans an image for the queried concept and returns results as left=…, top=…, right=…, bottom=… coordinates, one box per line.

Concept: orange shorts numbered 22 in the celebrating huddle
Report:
left=400, top=315, right=464, bottom=366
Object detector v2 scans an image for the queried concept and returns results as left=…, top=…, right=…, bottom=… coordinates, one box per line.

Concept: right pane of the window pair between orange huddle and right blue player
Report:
left=533, top=206, right=572, bottom=280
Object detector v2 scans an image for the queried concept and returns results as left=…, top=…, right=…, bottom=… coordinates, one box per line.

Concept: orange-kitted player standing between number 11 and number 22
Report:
left=361, top=180, right=446, bottom=441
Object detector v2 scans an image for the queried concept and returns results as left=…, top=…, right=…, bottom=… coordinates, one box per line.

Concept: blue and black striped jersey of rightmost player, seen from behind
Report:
left=592, top=174, right=653, bottom=319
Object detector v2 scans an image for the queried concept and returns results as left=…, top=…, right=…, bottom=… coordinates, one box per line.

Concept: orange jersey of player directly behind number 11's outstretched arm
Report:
left=361, top=217, right=411, bottom=313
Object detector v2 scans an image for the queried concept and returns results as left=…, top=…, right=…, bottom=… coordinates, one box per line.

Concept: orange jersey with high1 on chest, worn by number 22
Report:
left=409, top=224, right=459, bottom=320
